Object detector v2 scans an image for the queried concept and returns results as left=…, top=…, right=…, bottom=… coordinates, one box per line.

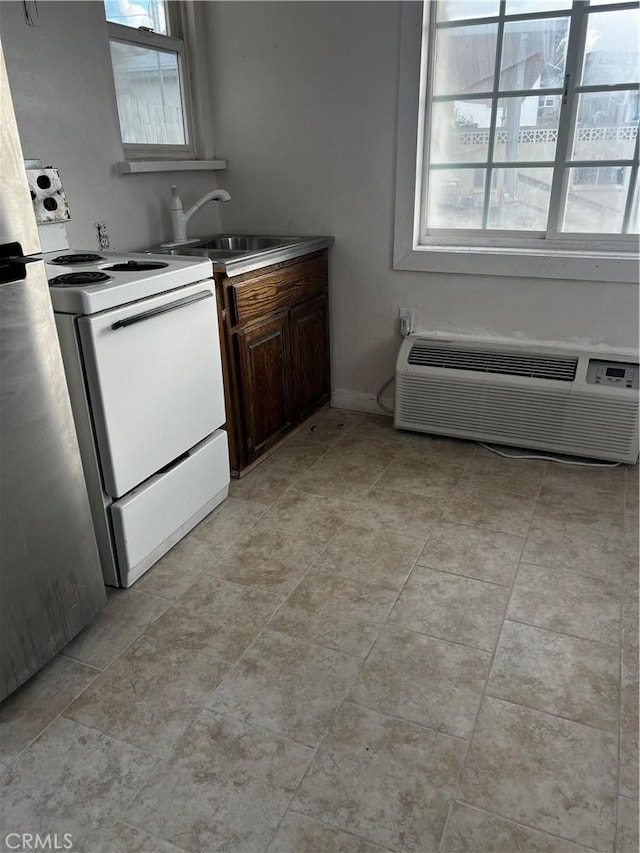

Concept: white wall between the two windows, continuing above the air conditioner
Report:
left=207, top=2, right=638, bottom=402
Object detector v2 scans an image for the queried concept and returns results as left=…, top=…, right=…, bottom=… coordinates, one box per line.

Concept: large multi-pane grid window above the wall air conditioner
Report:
left=396, top=0, right=640, bottom=278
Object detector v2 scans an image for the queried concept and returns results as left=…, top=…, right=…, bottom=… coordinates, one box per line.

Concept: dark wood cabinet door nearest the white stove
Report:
left=236, top=311, right=291, bottom=462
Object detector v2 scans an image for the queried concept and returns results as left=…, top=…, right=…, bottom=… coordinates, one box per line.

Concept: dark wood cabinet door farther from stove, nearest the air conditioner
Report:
left=291, top=296, right=331, bottom=419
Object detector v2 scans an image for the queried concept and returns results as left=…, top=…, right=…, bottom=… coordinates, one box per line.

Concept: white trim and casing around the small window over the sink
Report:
left=107, top=0, right=214, bottom=162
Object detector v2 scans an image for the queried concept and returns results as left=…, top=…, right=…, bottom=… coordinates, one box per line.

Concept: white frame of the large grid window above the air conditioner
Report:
left=393, top=0, right=638, bottom=283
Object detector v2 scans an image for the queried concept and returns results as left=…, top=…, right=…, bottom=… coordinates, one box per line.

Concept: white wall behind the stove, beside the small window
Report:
left=0, top=0, right=224, bottom=250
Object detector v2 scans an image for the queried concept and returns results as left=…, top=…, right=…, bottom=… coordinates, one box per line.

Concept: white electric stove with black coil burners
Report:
left=43, top=248, right=229, bottom=587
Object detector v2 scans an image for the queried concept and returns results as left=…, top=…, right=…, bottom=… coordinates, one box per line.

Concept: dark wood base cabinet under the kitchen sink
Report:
left=216, top=250, right=330, bottom=475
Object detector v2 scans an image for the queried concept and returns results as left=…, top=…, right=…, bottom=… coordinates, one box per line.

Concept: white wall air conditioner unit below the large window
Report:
left=394, top=335, right=639, bottom=463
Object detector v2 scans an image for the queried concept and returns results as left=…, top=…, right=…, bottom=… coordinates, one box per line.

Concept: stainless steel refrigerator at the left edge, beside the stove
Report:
left=0, top=44, right=106, bottom=699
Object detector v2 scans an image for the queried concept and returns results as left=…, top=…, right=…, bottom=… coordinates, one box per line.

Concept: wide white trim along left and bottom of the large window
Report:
left=393, top=2, right=639, bottom=284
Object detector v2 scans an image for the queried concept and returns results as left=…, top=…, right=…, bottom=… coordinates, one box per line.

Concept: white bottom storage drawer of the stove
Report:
left=111, top=430, right=229, bottom=587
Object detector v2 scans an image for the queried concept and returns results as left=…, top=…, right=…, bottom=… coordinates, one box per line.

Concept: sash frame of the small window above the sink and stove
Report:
left=107, top=0, right=199, bottom=161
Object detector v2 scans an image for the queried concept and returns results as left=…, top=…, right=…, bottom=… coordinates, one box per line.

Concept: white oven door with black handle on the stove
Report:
left=78, top=281, right=225, bottom=498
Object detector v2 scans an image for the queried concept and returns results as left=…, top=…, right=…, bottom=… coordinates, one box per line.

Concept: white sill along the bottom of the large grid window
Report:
left=393, top=246, right=638, bottom=284
